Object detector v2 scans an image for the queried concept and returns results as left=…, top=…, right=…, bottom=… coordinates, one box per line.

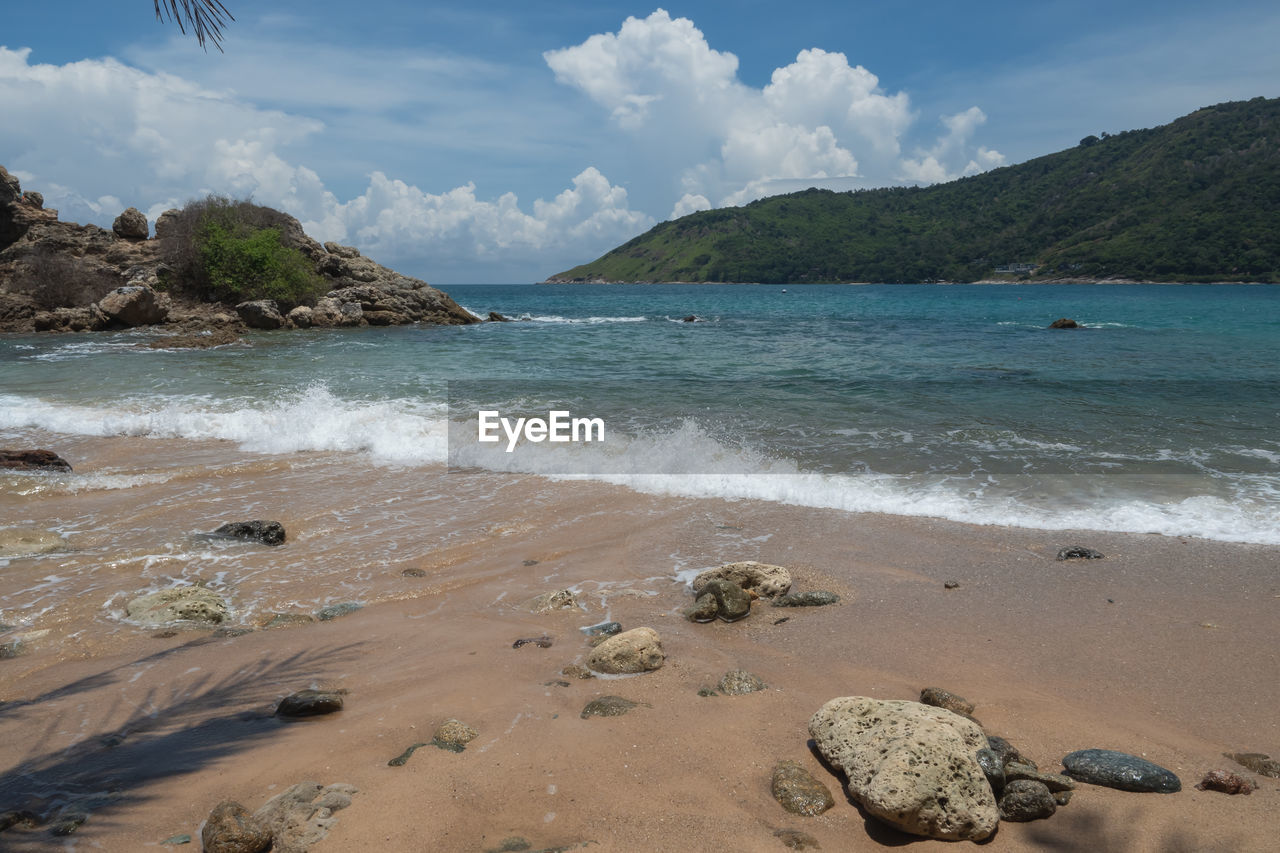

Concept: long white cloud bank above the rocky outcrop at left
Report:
left=0, top=47, right=653, bottom=278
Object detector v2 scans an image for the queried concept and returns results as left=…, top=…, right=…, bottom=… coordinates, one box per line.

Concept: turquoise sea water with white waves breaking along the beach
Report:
left=0, top=284, right=1280, bottom=543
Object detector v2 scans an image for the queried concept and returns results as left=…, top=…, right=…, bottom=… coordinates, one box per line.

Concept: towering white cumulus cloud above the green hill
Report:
left=543, top=9, right=1002, bottom=214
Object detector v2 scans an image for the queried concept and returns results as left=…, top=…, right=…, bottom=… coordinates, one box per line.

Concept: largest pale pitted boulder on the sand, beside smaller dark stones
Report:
left=809, top=697, right=1000, bottom=841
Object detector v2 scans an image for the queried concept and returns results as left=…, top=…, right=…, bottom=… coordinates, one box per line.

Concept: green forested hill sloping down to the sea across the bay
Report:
left=548, top=97, right=1280, bottom=283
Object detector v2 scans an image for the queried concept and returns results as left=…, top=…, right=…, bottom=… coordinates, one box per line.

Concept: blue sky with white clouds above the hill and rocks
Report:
left=0, top=0, right=1280, bottom=284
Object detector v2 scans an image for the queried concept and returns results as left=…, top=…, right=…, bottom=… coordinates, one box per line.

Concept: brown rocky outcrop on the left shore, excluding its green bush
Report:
left=0, top=167, right=480, bottom=332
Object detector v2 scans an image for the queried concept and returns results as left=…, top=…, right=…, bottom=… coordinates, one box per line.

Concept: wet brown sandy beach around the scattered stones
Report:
left=0, top=433, right=1280, bottom=852
